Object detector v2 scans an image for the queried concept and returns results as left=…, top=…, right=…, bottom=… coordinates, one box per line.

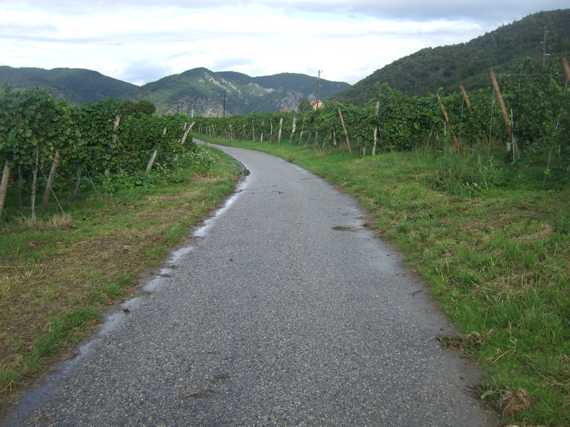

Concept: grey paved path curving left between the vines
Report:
left=4, top=148, right=490, bottom=427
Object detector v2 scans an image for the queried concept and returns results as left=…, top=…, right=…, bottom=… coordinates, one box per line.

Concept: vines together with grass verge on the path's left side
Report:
left=0, top=85, right=245, bottom=412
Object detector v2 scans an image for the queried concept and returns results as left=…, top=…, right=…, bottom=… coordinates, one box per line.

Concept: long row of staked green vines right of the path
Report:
left=196, top=59, right=570, bottom=172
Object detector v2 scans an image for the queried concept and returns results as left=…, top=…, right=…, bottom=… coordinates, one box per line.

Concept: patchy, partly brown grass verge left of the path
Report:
left=0, top=146, right=240, bottom=409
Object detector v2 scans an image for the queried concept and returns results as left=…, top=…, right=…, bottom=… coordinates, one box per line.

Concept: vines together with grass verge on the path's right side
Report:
left=196, top=60, right=570, bottom=426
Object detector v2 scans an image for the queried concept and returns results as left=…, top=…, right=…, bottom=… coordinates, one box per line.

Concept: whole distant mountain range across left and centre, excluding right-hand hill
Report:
left=0, top=66, right=350, bottom=115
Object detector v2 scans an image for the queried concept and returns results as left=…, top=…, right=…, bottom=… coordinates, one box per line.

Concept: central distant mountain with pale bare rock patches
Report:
left=139, top=68, right=350, bottom=116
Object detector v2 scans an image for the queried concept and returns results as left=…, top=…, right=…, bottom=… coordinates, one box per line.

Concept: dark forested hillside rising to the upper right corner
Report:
left=337, top=9, right=570, bottom=102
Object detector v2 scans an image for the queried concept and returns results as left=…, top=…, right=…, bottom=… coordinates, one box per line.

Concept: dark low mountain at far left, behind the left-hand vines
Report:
left=0, top=66, right=139, bottom=103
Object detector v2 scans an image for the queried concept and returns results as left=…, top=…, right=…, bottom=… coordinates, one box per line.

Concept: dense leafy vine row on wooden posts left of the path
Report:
left=0, top=88, right=192, bottom=221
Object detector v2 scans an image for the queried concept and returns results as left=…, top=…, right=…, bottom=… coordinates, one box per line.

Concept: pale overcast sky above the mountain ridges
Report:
left=0, top=0, right=568, bottom=84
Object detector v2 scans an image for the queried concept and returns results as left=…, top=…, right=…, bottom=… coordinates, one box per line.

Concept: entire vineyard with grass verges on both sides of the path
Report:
left=0, top=52, right=570, bottom=425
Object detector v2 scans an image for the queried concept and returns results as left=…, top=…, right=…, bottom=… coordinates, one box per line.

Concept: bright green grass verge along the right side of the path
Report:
left=200, top=138, right=570, bottom=426
